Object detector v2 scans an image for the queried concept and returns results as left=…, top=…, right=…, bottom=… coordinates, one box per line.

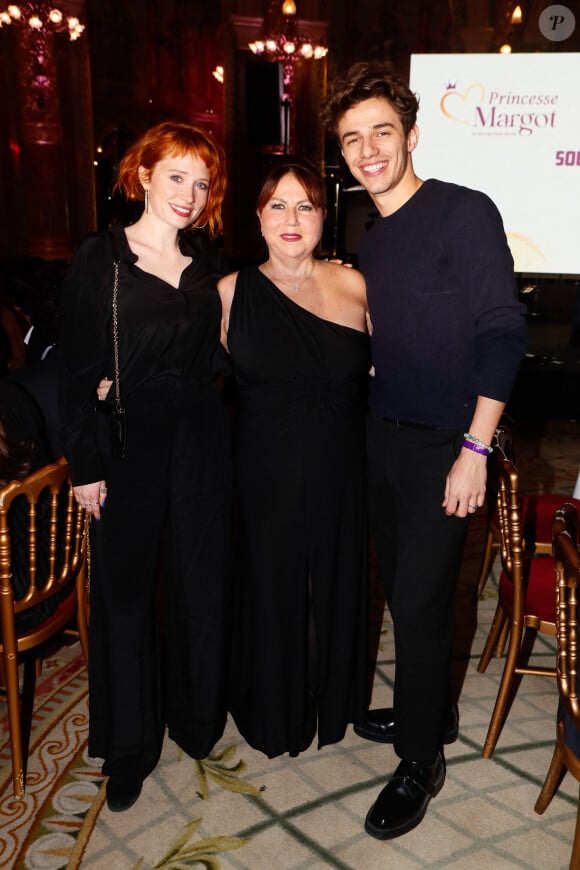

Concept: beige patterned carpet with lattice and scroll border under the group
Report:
left=0, top=424, right=580, bottom=870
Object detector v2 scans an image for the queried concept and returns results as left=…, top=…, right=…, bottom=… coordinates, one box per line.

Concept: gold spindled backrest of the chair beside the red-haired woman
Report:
left=0, top=459, right=86, bottom=651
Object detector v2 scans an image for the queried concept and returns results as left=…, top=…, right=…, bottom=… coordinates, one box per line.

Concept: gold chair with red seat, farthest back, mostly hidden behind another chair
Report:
left=477, top=426, right=580, bottom=600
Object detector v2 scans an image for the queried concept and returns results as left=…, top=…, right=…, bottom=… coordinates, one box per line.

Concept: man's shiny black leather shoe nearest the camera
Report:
left=365, top=752, right=445, bottom=840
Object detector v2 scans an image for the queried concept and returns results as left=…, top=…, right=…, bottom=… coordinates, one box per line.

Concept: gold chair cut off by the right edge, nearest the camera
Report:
left=534, top=504, right=580, bottom=870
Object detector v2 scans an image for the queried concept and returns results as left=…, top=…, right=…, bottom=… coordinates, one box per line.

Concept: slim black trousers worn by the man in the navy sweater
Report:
left=367, top=412, right=467, bottom=764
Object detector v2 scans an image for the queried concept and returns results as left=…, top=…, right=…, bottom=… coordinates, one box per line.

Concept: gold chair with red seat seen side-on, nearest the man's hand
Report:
left=477, top=440, right=565, bottom=758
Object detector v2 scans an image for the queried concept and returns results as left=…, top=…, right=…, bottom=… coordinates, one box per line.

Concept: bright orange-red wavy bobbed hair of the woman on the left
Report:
left=115, top=121, right=227, bottom=239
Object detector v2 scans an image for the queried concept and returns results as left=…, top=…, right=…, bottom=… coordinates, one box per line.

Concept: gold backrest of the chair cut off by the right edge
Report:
left=553, top=504, right=580, bottom=728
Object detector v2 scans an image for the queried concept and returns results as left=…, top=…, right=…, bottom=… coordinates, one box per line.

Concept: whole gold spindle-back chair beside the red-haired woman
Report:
left=0, top=459, right=88, bottom=798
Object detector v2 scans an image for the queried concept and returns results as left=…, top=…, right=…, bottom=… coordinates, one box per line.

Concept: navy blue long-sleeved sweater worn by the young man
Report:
left=360, top=179, right=527, bottom=428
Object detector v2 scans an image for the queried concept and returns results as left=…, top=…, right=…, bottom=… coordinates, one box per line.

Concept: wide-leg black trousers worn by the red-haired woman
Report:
left=89, top=380, right=231, bottom=778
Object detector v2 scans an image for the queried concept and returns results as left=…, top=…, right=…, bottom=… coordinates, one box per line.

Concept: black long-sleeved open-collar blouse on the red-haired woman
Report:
left=61, top=227, right=221, bottom=485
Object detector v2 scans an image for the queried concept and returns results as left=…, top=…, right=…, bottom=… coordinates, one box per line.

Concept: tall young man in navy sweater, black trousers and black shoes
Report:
left=323, top=63, right=526, bottom=839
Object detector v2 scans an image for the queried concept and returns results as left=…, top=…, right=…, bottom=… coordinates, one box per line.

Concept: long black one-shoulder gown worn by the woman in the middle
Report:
left=228, top=267, right=370, bottom=757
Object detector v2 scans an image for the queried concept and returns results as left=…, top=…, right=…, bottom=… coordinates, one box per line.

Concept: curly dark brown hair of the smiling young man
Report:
left=320, top=61, right=419, bottom=136
